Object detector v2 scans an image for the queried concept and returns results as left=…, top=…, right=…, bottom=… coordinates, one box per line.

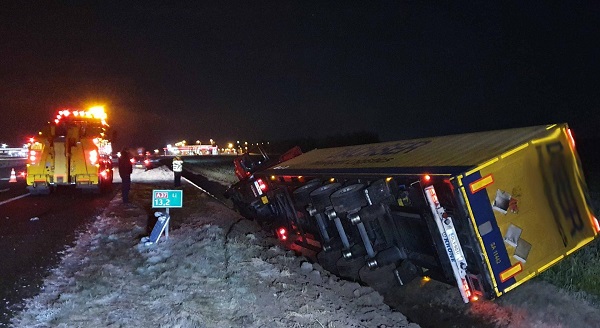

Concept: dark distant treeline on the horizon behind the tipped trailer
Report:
left=265, top=131, right=380, bottom=154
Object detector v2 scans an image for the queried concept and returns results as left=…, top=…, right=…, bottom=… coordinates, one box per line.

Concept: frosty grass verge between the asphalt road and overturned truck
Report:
left=12, top=168, right=417, bottom=328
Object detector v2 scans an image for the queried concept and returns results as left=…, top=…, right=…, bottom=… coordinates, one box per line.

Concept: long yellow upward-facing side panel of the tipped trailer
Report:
left=266, top=123, right=567, bottom=175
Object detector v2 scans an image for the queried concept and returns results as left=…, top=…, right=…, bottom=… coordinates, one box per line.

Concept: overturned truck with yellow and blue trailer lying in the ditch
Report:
left=227, top=124, right=600, bottom=303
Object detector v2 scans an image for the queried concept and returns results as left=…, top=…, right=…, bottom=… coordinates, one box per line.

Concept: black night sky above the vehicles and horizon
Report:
left=0, top=1, right=600, bottom=147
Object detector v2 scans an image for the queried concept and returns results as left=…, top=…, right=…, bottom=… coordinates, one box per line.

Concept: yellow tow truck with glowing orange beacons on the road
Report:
left=27, top=106, right=113, bottom=195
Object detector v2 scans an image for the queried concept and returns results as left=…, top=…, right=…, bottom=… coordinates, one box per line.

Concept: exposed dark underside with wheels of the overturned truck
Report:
left=232, top=175, right=493, bottom=298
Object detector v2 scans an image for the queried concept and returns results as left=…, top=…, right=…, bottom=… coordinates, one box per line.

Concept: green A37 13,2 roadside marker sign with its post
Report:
left=142, top=190, right=183, bottom=245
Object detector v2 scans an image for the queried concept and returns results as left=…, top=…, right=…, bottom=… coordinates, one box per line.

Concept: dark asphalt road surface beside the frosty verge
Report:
left=0, top=179, right=117, bottom=326
